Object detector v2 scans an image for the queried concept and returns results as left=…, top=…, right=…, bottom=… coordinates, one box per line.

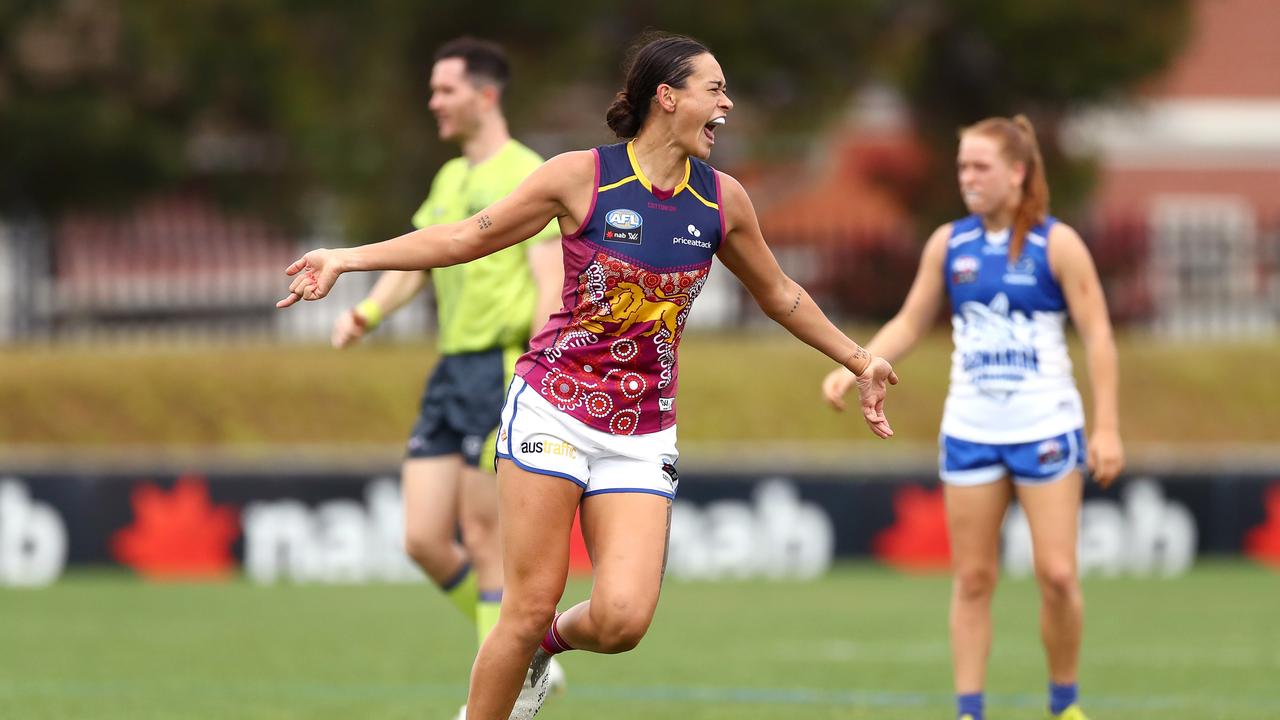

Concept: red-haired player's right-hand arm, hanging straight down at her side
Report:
left=1048, top=223, right=1124, bottom=487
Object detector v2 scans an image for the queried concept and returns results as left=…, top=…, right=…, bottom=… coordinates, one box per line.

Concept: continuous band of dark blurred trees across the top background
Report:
left=0, top=0, right=1188, bottom=241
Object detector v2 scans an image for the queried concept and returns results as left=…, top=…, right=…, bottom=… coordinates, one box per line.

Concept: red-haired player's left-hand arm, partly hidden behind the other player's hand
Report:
left=822, top=223, right=951, bottom=410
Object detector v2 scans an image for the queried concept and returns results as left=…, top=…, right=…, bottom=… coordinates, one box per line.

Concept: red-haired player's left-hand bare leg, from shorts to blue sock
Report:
left=943, top=478, right=1012, bottom=694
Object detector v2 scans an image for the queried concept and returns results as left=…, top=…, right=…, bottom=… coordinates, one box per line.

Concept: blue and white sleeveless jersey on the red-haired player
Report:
left=942, top=215, right=1084, bottom=443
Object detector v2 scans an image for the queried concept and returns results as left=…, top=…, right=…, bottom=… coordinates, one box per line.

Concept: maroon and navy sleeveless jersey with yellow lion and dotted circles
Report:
left=516, top=143, right=724, bottom=434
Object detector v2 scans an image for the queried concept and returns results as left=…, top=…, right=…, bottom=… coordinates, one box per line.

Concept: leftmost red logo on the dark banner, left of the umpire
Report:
left=111, top=475, right=239, bottom=580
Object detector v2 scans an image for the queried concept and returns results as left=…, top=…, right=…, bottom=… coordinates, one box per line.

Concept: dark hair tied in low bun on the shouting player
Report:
left=604, top=33, right=710, bottom=140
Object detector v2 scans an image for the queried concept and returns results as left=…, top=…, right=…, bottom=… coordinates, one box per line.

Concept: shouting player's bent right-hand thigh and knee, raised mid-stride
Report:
left=556, top=493, right=671, bottom=653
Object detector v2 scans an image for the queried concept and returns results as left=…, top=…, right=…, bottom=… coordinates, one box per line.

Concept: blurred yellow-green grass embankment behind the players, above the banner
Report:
left=0, top=331, right=1280, bottom=448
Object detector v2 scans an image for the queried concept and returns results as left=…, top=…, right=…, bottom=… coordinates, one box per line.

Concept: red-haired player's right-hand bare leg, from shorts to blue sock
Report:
left=1016, top=471, right=1084, bottom=684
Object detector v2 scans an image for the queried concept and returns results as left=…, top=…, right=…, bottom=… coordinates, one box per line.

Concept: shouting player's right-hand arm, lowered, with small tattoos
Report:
left=717, top=173, right=897, bottom=438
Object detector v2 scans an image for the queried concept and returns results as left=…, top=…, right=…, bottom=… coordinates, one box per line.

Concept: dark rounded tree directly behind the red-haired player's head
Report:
left=881, top=0, right=1190, bottom=223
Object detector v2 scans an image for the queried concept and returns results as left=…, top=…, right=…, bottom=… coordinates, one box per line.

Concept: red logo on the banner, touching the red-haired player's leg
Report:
left=872, top=486, right=951, bottom=571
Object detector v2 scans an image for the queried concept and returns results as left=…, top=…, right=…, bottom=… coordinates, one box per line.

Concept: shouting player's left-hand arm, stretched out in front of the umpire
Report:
left=275, top=151, right=595, bottom=307
